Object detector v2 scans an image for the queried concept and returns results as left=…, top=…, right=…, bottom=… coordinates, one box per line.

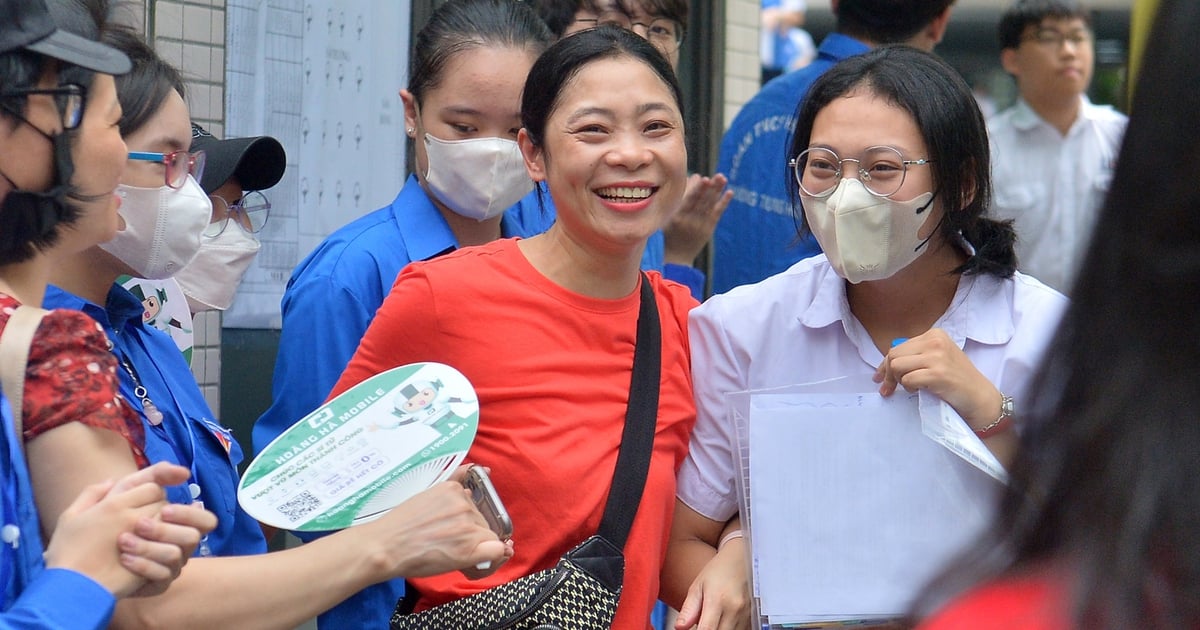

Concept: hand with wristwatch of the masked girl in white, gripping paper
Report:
left=874, top=328, right=1002, bottom=428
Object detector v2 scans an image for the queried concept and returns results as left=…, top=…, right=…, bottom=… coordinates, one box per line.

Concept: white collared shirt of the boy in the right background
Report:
left=988, top=96, right=1128, bottom=292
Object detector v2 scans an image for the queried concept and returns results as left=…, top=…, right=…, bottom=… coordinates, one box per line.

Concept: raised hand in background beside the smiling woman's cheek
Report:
left=662, top=173, right=733, bottom=266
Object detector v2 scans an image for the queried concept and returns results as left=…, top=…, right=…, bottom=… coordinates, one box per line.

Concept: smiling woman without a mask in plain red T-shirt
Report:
left=332, top=28, right=696, bottom=630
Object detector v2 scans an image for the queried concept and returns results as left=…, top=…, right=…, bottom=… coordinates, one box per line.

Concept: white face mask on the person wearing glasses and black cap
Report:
left=175, top=224, right=263, bottom=313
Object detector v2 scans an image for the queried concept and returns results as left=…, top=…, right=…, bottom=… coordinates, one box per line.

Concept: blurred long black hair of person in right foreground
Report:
left=912, top=0, right=1200, bottom=630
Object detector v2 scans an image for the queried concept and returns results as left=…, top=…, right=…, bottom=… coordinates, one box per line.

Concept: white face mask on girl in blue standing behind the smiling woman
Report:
left=425, top=133, right=533, bottom=221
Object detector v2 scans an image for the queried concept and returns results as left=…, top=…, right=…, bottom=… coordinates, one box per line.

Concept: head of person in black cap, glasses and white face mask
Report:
left=175, top=122, right=287, bottom=314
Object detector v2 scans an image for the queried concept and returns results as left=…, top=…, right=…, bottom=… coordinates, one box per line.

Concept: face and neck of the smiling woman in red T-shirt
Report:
left=520, top=28, right=688, bottom=298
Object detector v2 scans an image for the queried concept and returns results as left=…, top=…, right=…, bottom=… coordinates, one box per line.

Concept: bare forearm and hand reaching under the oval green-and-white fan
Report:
left=108, top=476, right=505, bottom=630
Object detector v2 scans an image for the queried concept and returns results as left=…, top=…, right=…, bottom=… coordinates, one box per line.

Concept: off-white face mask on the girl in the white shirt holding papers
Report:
left=803, top=178, right=934, bottom=284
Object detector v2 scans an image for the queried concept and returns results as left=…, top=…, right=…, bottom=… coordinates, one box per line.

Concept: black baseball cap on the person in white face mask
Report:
left=191, top=122, right=288, bottom=194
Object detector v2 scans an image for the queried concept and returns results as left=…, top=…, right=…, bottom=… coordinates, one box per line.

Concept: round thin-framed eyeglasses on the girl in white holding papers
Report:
left=787, top=146, right=932, bottom=197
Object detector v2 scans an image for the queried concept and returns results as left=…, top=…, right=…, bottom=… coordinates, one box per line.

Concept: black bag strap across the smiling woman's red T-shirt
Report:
left=599, top=272, right=662, bottom=550
